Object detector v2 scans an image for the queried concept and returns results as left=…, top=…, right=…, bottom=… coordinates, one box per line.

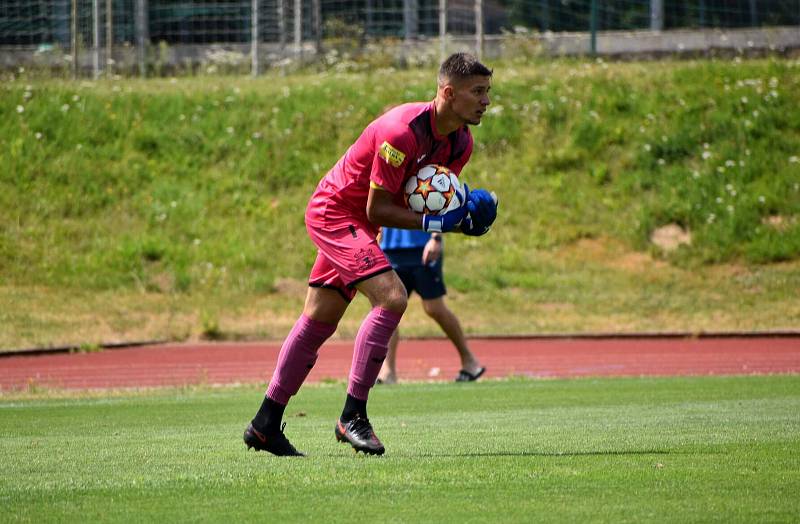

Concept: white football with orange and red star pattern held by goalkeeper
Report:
left=405, top=164, right=464, bottom=215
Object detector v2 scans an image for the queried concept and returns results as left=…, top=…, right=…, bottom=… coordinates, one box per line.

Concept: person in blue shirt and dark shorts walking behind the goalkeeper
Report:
left=378, top=227, right=486, bottom=384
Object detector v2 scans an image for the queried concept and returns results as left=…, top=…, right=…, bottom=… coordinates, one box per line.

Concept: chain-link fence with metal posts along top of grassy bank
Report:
left=0, top=0, right=800, bottom=76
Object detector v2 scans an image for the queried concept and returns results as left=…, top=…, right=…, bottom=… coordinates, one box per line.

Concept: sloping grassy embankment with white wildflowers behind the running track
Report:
left=0, top=59, right=800, bottom=348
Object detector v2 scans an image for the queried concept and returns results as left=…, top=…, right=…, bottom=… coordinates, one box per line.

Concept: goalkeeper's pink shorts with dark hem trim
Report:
left=306, top=221, right=392, bottom=302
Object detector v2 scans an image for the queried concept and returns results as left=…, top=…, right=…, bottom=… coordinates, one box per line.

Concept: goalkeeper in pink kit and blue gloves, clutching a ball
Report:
left=244, top=53, right=497, bottom=455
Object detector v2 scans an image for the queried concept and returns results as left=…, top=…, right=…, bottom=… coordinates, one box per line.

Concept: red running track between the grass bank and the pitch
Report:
left=0, top=337, right=800, bottom=392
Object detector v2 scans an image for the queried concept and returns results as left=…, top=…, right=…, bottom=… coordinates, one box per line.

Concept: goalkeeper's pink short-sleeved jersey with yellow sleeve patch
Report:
left=306, top=102, right=472, bottom=234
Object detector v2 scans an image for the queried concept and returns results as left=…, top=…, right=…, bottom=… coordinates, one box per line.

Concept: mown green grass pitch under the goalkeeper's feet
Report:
left=0, top=376, right=800, bottom=522
